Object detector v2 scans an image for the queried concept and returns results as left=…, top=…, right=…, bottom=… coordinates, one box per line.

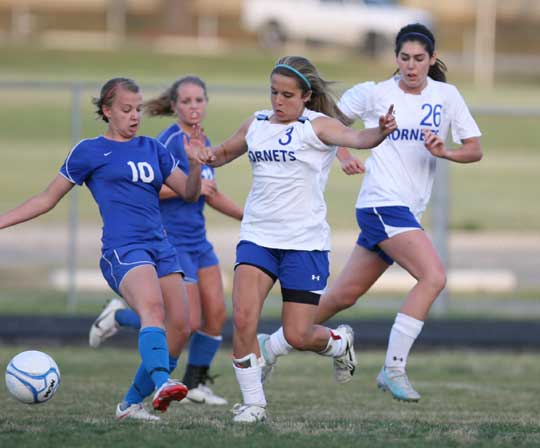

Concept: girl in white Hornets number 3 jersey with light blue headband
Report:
left=198, top=56, right=396, bottom=423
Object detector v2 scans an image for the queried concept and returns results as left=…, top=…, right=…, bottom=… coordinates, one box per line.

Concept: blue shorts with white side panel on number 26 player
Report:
left=356, top=205, right=422, bottom=264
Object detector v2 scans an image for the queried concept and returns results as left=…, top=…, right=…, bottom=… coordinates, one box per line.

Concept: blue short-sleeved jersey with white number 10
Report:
left=60, top=136, right=177, bottom=250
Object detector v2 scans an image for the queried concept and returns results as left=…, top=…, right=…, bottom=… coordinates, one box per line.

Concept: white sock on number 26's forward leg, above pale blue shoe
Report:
left=384, top=313, right=424, bottom=371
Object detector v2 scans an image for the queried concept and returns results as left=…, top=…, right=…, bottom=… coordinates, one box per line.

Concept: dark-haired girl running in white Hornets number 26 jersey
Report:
left=260, top=24, right=482, bottom=401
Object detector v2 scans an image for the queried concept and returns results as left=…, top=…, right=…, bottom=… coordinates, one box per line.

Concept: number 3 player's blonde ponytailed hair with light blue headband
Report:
left=270, top=56, right=352, bottom=126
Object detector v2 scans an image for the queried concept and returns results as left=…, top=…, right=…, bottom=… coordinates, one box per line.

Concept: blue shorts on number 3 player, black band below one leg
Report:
left=235, top=241, right=330, bottom=305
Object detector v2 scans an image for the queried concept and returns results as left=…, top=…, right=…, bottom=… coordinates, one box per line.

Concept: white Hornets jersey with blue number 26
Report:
left=339, top=78, right=481, bottom=221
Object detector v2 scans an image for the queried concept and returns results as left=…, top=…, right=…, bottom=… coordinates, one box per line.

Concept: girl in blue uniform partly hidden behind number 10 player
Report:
left=90, top=76, right=243, bottom=405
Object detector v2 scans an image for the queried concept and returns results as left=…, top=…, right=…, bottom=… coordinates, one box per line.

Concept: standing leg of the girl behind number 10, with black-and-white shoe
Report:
left=184, top=260, right=227, bottom=405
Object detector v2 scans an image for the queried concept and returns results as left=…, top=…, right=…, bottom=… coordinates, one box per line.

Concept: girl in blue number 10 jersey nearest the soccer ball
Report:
left=0, top=78, right=212, bottom=420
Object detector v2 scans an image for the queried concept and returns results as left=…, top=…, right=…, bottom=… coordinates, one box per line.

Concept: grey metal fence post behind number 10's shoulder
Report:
left=67, top=83, right=83, bottom=314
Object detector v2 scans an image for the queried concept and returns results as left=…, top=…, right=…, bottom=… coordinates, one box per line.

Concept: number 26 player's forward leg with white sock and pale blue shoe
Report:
left=377, top=230, right=446, bottom=401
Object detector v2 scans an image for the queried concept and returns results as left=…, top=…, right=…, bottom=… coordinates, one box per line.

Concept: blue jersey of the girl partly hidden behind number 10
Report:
left=157, top=123, right=214, bottom=251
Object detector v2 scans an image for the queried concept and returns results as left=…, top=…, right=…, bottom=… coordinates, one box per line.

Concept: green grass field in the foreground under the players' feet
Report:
left=0, top=346, right=540, bottom=448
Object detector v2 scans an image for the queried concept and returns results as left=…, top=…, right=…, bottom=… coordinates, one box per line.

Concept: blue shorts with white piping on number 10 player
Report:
left=99, top=240, right=184, bottom=297
